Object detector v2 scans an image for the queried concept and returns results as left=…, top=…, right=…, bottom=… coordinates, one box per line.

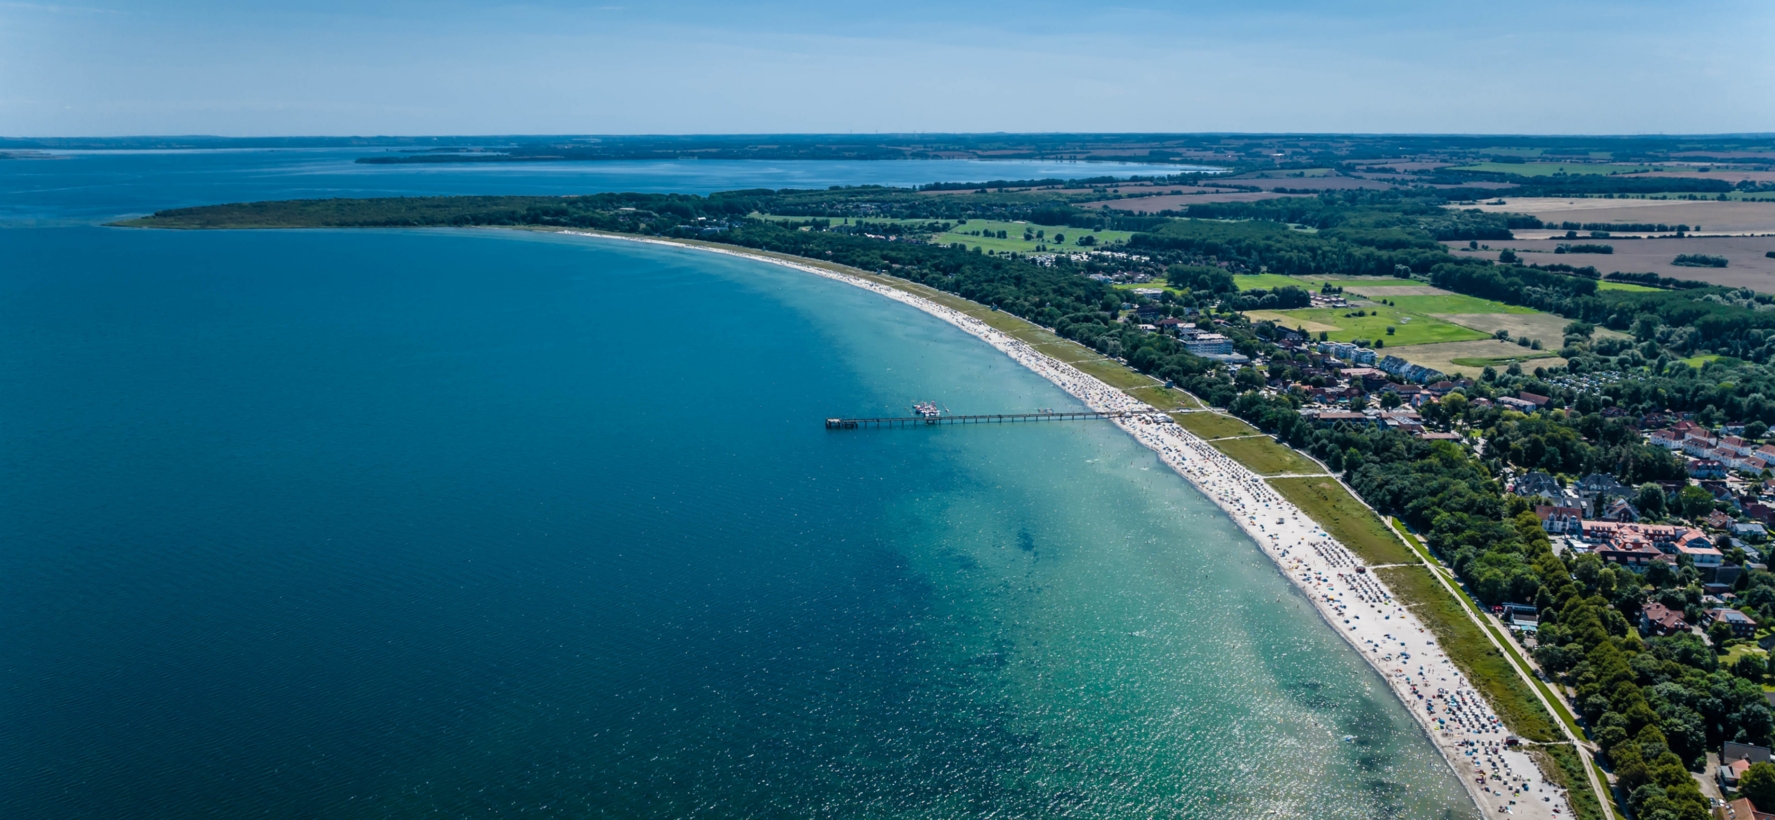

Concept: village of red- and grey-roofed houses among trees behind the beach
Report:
left=1086, top=260, right=1775, bottom=820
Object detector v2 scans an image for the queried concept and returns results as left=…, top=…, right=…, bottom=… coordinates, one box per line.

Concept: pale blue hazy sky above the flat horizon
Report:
left=0, top=0, right=1775, bottom=137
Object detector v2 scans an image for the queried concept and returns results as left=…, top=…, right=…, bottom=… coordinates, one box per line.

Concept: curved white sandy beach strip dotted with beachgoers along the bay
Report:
left=552, top=231, right=1573, bottom=820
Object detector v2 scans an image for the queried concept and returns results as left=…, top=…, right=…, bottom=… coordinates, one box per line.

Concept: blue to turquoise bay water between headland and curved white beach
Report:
left=0, top=155, right=1473, bottom=818
